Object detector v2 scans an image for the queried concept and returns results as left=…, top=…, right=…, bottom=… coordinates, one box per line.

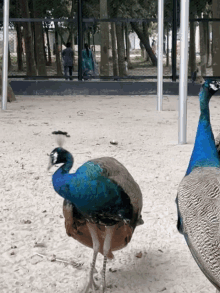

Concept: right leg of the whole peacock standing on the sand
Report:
left=102, top=226, right=115, bottom=293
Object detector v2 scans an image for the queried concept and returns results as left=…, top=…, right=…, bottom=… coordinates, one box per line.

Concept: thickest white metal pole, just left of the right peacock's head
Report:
left=178, top=0, right=189, bottom=144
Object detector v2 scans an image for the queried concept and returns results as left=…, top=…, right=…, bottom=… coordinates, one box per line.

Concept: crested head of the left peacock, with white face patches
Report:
left=47, top=131, right=73, bottom=170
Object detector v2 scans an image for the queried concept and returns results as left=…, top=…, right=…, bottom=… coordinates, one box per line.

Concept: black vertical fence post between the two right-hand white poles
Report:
left=172, top=0, right=177, bottom=81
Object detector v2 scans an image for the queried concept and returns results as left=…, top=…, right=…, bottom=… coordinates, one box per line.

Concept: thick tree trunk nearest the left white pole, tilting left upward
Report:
left=20, top=0, right=37, bottom=76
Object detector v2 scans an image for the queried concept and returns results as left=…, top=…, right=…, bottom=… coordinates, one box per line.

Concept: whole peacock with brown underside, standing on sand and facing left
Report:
left=48, top=131, right=144, bottom=293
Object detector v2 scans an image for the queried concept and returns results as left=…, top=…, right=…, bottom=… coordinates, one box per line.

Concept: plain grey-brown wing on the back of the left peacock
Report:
left=92, top=157, right=143, bottom=224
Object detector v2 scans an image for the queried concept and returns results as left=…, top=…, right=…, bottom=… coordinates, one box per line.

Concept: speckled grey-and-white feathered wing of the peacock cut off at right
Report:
left=177, top=167, right=220, bottom=290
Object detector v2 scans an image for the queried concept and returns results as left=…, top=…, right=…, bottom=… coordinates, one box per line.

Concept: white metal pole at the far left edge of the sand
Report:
left=2, top=0, right=9, bottom=110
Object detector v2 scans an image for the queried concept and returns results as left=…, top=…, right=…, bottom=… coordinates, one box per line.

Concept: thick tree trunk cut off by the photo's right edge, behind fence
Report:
left=212, top=0, right=220, bottom=76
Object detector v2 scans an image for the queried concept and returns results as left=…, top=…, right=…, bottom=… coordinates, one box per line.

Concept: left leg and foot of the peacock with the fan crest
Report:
left=83, top=223, right=100, bottom=293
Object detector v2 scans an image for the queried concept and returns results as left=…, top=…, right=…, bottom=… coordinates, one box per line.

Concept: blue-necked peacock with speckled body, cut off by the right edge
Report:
left=176, top=79, right=220, bottom=292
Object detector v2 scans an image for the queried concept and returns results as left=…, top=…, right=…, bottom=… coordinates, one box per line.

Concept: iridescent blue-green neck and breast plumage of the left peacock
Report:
left=53, top=162, right=132, bottom=225
